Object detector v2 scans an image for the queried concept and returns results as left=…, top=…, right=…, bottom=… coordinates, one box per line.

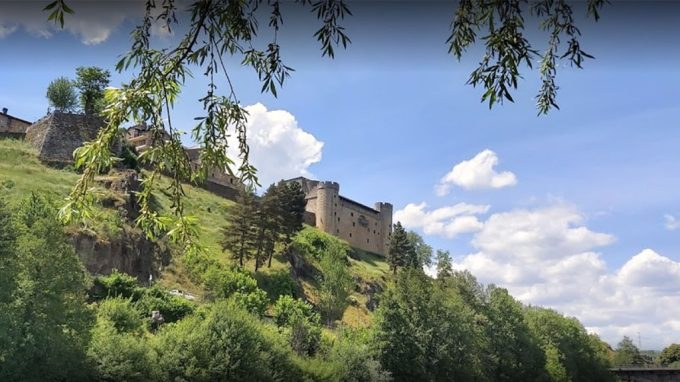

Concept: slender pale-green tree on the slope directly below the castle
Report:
left=318, top=245, right=354, bottom=325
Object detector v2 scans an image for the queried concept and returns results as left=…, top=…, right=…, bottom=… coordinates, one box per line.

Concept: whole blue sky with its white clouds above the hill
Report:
left=0, top=1, right=680, bottom=349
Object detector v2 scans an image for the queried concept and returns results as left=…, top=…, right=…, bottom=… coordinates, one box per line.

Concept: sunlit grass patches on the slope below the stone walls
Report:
left=0, top=139, right=388, bottom=326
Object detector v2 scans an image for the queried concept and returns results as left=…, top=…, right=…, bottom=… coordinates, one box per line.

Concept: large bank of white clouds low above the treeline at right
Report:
left=446, top=205, right=680, bottom=349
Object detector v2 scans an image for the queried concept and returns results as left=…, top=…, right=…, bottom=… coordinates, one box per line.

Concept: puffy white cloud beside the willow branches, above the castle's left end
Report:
left=229, top=103, right=323, bottom=187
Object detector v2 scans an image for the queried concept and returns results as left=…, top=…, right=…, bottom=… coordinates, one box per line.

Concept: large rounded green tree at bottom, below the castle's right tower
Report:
left=374, top=269, right=480, bottom=381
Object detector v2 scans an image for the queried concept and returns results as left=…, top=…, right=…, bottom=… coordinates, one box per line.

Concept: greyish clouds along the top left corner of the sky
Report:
left=0, top=1, right=168, bottom=45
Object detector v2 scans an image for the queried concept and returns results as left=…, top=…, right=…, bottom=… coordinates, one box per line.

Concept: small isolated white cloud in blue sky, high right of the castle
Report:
left=435, top=149, right=517, bottom=196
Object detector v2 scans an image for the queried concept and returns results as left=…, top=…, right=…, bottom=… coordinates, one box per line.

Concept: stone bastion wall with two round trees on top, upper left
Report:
left=25, top=111, right=104, bottom=165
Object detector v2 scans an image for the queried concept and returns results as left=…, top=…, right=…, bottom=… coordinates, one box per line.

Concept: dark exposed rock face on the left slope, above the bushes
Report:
left=71, top=228, right=170, bottom=283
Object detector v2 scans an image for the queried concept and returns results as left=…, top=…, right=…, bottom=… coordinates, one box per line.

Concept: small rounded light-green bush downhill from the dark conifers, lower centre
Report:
left=274, top=296, right=321, bottom=355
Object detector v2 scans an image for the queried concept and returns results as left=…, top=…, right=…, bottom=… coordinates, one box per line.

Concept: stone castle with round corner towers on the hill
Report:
left=288, top=177, right=392, bottom=256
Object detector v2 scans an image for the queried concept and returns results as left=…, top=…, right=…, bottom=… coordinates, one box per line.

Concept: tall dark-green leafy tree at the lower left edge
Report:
left=0, top=194, right=94, bottom=381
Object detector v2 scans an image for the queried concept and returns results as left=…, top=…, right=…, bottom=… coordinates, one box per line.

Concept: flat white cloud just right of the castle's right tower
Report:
left=394, top=202, right=490, bottom=238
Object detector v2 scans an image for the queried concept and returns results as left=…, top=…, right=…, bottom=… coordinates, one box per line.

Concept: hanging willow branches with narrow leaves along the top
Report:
left=54, top=0, right=607, bottom=251
